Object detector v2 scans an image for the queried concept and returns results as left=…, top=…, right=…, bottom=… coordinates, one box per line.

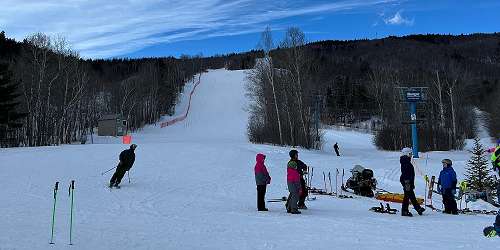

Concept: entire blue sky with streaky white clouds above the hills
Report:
left=0, top=0, right=500, bottom=58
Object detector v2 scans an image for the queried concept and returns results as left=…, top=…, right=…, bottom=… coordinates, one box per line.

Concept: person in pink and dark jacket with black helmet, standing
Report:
left=285, top=149, right=301, bottom=214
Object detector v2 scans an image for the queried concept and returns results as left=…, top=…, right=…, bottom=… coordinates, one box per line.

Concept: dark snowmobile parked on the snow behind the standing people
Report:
left=345, top=165, right=377, bottom=197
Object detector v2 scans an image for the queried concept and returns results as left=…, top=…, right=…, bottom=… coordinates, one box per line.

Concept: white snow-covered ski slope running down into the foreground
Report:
left=0, top=70, right=499, bottom=250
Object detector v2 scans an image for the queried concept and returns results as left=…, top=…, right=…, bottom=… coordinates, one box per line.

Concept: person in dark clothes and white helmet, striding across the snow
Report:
left=399, top=148, right=425, bottom=217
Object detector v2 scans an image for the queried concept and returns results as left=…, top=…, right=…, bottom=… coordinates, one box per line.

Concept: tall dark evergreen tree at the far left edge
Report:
left=0, top=63, right=25, bottom=146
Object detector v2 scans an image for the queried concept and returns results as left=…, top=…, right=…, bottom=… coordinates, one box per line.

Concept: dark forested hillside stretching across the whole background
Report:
left=0, top=32, right=500, bottom=150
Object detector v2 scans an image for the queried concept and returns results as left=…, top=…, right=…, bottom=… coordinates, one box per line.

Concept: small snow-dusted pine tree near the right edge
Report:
left=465, top=137, right=496, bottom=192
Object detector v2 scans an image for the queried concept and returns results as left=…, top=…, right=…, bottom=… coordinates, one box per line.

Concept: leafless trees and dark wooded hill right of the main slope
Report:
left=249, top=28, right=500, bottom=151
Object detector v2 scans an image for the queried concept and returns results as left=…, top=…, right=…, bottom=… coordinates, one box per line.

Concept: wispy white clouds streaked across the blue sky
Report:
left=0, top=0, right=398, bottom=58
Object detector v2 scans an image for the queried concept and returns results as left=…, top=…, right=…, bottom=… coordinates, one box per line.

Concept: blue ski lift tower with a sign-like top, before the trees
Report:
left=398, top=87, right=427, bottom=158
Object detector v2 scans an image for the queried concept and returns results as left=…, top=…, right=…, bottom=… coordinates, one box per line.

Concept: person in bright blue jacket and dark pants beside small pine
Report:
left=438, top=159, right=458, bottom=214
